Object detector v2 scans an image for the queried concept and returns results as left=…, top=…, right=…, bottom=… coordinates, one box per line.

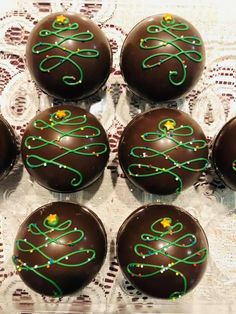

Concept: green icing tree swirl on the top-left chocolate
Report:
left=32, top=17, right=100, bottom=86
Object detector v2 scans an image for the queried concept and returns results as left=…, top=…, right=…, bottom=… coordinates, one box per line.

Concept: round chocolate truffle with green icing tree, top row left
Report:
left=26, top=12, right=112, bottom=99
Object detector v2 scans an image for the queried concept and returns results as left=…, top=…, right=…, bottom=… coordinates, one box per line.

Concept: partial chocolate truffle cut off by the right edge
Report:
left=212, top=117, right=236, bottom=191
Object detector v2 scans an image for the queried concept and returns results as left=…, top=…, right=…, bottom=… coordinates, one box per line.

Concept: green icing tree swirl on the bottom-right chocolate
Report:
left=127, top=217, right=208, bottom=299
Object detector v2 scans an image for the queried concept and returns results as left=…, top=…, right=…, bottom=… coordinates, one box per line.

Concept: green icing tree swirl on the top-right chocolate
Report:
left=140, top=19, right=203, bottom=86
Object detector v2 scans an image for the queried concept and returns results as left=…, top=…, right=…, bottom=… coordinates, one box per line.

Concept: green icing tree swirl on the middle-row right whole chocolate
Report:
left=128, top=119, right=208, bottom=193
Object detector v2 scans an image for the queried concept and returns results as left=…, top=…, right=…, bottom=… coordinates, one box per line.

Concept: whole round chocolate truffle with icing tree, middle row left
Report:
left=21, top=105, right=109, bottom=192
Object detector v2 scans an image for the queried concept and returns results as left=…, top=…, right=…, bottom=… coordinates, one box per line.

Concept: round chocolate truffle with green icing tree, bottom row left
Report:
left=13, top=202, right=107, bottom=297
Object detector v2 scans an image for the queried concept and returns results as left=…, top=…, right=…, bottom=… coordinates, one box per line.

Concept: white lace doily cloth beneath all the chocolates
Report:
left=0, top=0, right=236, bottom=314
